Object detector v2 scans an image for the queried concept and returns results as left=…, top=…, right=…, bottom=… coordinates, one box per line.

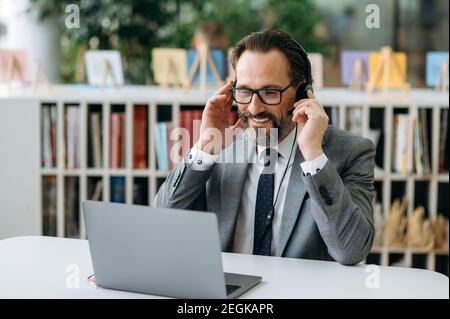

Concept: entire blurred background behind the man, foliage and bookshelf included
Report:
left=0, top=0, right=449, bottom=276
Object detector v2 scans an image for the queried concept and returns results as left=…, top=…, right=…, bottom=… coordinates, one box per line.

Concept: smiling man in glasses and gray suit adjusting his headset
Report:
left=155, top=30, right=375, bottom=265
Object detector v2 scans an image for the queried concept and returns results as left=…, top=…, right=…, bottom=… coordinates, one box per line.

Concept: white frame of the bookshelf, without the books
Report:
left=0, top=86, right=449, bottom=273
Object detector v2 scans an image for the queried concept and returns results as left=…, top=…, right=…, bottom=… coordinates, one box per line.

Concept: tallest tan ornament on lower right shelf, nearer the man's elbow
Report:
left=385, top=198, right=408, bottom=247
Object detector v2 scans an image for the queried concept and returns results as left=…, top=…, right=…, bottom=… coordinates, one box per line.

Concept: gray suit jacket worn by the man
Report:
left=154, top=125, right=375, bottom=265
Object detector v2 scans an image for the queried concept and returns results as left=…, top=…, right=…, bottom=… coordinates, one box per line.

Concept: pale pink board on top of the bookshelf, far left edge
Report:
left=0, top=50, right=29, bottom=85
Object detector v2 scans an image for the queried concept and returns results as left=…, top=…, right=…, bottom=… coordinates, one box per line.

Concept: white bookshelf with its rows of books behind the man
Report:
left=0, top=86, right=449, bottom=275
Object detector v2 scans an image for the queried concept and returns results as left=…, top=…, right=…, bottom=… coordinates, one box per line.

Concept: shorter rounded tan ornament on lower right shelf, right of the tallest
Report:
left=407, top=206, right=434, bottom=250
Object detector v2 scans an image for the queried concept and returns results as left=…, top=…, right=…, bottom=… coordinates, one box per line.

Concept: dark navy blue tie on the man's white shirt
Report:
left=253, top=148, right=278, bottom=256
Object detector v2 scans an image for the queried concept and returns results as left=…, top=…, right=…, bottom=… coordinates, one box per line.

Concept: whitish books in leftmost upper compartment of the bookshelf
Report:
left=41, top=105, right=56, bottom=168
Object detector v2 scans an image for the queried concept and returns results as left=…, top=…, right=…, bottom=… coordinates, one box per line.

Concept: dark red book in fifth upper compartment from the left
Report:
left=133, top=105, right=148, bottom=168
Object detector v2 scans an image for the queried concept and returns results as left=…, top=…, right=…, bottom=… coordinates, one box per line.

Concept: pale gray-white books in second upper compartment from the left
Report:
left=66, top=105, right=80, bottom=169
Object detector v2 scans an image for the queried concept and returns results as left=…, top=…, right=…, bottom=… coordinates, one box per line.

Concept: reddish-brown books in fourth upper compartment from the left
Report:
left=109, top=112, right=125, bottom=168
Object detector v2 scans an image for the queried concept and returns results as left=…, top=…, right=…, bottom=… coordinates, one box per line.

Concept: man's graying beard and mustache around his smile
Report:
left=238, top=109, right=295, bottom=147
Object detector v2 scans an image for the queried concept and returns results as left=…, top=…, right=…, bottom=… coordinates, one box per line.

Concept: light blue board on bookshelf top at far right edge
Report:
left=426, top=52, right=449, bottom=92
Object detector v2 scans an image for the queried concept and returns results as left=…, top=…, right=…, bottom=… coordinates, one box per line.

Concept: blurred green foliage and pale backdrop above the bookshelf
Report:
left=0, top=0, right=449, bottom=87
